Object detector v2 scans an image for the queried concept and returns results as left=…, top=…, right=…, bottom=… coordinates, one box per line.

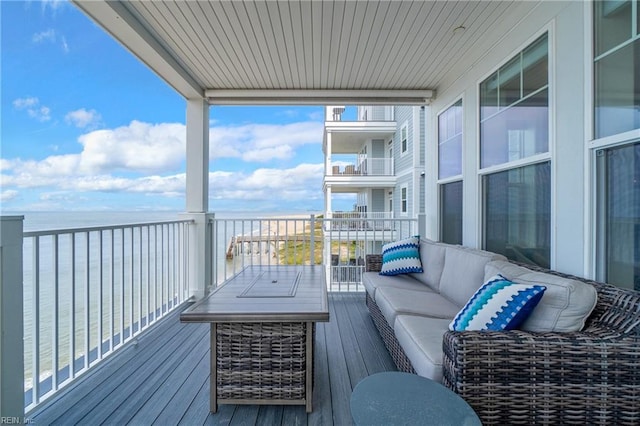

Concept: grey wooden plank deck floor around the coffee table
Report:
left=29, top=293, right=395, bottom=426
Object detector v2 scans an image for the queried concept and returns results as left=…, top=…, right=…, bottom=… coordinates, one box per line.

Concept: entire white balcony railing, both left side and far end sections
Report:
left=15, top=215, right=417, bottom=413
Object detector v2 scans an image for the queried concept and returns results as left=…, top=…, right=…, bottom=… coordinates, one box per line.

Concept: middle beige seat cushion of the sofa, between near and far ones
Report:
left=375, top=287, right=460, bottom=327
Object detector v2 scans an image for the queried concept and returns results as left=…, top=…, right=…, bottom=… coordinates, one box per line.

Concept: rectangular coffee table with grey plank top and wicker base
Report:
left=180, top=265, right=329, bottom=413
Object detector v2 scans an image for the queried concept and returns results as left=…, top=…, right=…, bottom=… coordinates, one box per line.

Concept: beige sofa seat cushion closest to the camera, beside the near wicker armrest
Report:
left=393, top=315, right=449, bottom=383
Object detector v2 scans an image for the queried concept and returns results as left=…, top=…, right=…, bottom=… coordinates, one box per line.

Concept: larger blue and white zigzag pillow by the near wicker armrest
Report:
left=449, top=274, right=547, bottom=331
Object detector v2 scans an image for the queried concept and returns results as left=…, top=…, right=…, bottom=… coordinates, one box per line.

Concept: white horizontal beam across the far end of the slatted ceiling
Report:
left=205, top=89, right=435, bottom=105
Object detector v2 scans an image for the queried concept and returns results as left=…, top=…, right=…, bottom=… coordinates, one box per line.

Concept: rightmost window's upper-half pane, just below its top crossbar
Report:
left=595, top=40, right=640, bottom=138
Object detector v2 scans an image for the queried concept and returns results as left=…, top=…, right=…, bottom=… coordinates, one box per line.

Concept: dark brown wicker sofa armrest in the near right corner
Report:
left=443, top=329, right=640, bottom=424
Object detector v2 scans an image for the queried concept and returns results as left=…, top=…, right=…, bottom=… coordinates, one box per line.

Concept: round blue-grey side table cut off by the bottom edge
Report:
left=351, top=371, right=482, bottom=426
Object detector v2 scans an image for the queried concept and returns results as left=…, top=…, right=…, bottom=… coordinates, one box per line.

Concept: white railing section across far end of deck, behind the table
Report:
left=209, top=213, right=418, bottom=291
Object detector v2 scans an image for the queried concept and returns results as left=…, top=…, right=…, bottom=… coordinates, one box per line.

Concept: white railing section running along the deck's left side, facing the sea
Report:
left=23, top=221, right=191, bottom=411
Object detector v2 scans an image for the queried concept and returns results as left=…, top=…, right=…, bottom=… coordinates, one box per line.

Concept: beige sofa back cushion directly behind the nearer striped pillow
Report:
left=485, top=261, right=598, bottom=332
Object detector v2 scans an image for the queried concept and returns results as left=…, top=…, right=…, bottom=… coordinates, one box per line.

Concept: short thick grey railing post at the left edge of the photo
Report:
left=0, top=216, right=24, bottom=424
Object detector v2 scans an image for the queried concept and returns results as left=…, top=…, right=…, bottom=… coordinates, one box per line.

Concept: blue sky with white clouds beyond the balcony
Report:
left=0, top=1, right=353, bottom=211
